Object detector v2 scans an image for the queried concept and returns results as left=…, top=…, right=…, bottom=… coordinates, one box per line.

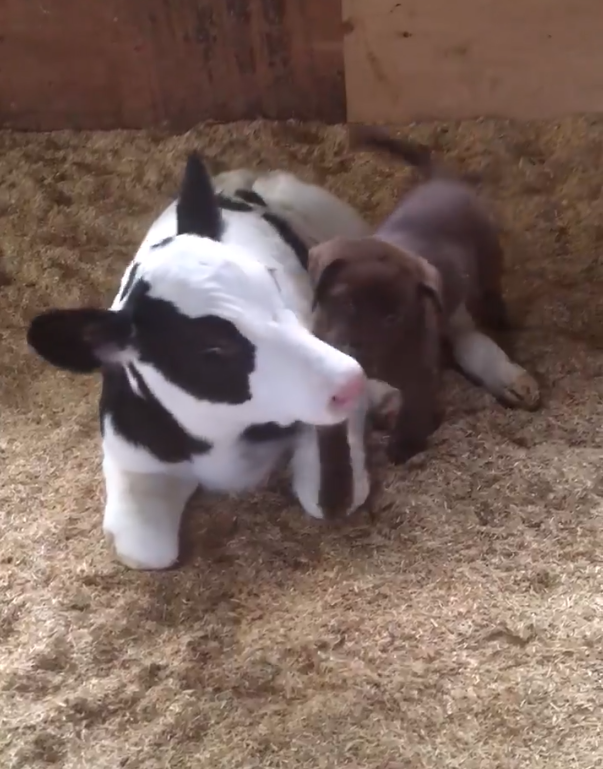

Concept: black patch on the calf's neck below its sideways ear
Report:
left=99, top=365, right=212, bottom=464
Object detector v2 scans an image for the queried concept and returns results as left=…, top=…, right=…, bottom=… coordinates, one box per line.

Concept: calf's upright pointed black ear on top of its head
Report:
left=176, top=152, right=222, bottom=240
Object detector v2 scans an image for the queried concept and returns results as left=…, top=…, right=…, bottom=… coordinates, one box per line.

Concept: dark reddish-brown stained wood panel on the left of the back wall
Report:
left=0, top=0, right=345, bottom=130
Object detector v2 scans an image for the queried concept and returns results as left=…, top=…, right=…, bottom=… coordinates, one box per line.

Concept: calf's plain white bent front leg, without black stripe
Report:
left=103, top=458, right=197, bottom=570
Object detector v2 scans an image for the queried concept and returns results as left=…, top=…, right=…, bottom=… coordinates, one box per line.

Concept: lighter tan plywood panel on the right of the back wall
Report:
left=343, top=0, right=603, bottom=122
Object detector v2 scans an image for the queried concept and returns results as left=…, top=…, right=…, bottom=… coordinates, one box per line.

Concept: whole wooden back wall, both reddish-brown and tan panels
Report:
left=0, top=0, right=603, bottom=130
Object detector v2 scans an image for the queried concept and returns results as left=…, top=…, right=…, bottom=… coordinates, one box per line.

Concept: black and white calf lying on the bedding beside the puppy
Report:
left=28, top=155, right=376, bottom=569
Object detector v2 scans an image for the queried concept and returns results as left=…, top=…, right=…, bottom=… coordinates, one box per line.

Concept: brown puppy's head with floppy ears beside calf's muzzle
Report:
left=309, top=238, right=442, bottom=384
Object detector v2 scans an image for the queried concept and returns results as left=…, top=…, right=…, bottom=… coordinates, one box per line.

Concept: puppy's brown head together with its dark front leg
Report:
left=310, top=238, right=442, bottom=461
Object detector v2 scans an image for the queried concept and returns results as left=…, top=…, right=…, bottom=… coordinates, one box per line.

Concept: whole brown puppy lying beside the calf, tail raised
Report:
left=310, top=129, right=539, bottom=462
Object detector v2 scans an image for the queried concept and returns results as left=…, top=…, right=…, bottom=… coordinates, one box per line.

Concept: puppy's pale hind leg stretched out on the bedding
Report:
left=450, top=306, right=540, bottom=411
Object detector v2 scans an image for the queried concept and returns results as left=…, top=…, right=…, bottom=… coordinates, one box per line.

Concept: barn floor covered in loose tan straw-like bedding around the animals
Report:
left=0, top=119, right=603, bottom=769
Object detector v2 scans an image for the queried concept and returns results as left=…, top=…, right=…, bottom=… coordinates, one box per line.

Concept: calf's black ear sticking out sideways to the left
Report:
left=27, top=308, right=133, bottom=374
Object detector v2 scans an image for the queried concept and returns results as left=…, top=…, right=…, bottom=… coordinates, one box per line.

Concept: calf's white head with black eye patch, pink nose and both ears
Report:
left=27, top=155, right=366, bottom=434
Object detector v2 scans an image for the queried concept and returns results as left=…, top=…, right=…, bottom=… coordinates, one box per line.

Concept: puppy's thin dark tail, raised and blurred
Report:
left=348, top=124, right=482, bottom=185
